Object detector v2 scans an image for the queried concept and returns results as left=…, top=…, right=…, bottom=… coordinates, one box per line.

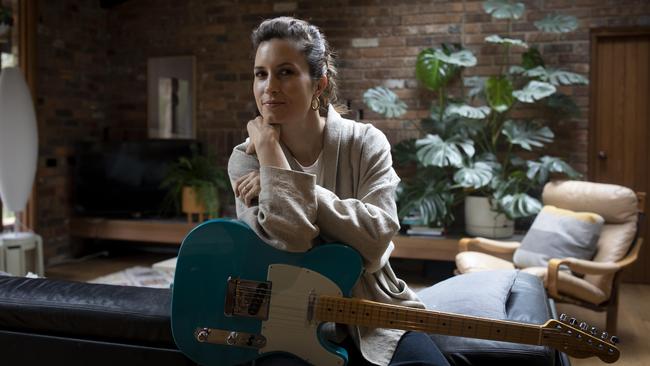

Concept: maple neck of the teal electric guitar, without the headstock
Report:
left=313, top=296, right=543, bottom=345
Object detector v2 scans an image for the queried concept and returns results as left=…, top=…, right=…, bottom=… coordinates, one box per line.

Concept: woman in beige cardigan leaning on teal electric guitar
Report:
left=228, top=17, right=447, bottom=365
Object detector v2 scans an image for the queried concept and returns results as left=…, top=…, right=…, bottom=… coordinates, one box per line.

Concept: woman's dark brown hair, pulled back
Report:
left=251, top=17, right=345, bottom=111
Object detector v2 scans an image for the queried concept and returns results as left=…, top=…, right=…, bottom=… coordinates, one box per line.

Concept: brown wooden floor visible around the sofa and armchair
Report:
left=46, top=252, right=650, bottom=366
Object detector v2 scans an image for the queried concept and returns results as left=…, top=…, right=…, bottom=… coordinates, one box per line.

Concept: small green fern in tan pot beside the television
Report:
left=161, top=149, right=230, bottom=222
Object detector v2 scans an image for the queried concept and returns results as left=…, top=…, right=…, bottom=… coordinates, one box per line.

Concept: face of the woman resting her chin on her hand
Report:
left=253, top=38, right=316, bottom=124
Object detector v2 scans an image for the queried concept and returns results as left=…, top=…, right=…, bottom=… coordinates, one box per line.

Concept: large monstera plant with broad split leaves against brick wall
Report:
left=364, top=0, right=588, bottom=232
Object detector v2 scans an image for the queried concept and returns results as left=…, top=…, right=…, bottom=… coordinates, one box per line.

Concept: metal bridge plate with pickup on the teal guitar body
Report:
left=224, top=277, right=271, bottom=320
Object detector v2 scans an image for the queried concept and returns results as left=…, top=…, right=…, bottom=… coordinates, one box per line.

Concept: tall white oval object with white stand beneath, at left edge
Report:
left=0, top=67, right=43, bottom=276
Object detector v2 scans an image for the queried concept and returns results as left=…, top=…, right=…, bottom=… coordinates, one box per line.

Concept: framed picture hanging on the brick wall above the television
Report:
left=147, top=56, right=196, bottom=138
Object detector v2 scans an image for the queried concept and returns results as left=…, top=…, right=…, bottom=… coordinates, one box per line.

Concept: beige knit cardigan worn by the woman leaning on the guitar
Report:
left=228, top=105, right=424, bottom=365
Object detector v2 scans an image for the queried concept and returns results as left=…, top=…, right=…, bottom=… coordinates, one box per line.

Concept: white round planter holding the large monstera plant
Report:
left=465, top=196, right=515, bottom=239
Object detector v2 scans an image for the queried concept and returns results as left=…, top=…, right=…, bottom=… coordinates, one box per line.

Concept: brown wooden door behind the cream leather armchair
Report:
left=588, top=28, right=650, bottom=283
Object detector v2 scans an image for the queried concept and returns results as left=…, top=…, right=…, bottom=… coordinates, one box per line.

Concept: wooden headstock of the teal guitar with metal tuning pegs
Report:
left=542, top=314, right=620, bottom=363
